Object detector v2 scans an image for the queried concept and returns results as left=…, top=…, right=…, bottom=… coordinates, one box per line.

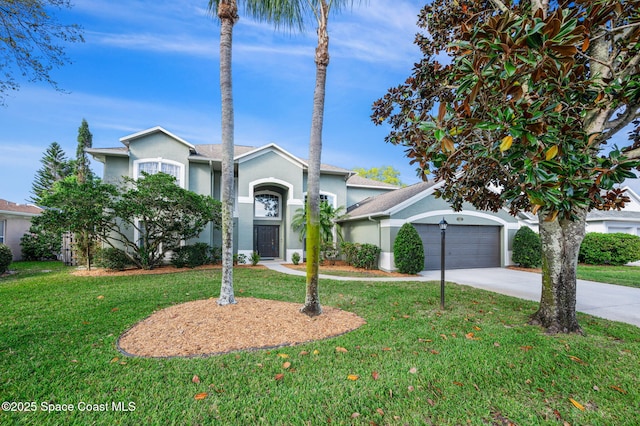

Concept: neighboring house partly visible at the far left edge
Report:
left=0, top=199, right=42, bottom=260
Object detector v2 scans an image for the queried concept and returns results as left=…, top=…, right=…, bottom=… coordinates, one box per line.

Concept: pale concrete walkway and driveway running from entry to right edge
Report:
left=262, top=261, right=640, bottom=327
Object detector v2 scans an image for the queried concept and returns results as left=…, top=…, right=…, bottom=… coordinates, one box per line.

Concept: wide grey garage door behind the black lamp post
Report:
left=414, top=225, right=500, bottom=270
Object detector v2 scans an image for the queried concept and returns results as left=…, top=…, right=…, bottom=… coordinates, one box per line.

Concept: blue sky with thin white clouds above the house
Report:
left=0, top=0, right=424, bottom=203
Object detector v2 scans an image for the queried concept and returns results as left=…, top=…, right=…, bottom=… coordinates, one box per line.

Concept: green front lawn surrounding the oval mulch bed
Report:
left=0, top=264, right=640, bottom=425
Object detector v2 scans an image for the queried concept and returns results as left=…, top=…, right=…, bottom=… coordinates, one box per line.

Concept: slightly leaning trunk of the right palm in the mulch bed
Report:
left=300, top=0, right=329, bottom=316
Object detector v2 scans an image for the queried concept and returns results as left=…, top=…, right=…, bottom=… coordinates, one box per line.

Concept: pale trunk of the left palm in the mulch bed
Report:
left=217, top=0, right=238, bottom=305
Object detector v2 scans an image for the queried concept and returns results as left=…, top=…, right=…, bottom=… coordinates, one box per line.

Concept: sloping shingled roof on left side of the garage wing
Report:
left=346, top=181, right=436, bottom=220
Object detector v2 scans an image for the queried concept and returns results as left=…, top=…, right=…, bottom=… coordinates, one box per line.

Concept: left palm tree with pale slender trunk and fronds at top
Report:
left=209, top=0, right=302, bottom=305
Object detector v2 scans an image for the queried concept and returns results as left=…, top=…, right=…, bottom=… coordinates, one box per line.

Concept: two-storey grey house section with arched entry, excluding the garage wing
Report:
left=87, top=127, right=397, bottom=260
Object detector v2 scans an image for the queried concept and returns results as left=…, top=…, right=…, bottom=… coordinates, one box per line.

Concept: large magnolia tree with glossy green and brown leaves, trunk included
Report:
left=372, top=0, right=640, bottom=332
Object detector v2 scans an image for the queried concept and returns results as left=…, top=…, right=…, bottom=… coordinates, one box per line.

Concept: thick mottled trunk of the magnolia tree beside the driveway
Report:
left=530, top=210, right=587, bottom=334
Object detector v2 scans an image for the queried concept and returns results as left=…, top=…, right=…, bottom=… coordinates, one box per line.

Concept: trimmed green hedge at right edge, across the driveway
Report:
left=578, top=232, right=640, bottom=265
